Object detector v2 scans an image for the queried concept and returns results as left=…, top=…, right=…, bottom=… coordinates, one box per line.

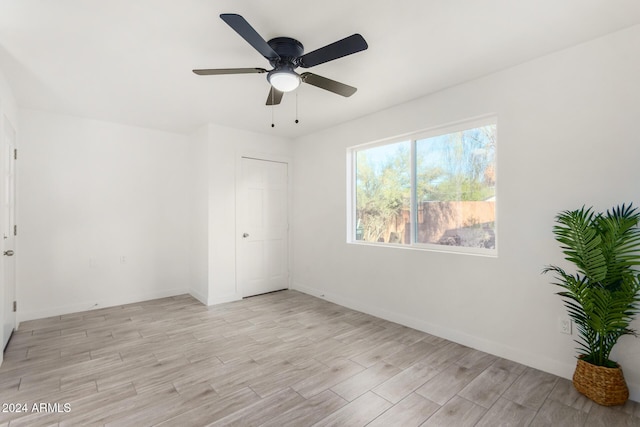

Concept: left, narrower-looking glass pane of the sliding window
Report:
left=355, top=141, right=411, bottom=244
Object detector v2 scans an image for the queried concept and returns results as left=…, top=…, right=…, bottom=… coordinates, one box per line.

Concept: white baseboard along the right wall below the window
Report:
left=292, top=283, right=640, bottom=402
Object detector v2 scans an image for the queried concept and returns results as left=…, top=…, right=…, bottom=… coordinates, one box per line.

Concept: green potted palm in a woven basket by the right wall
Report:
left=543, top=204, right=640, bottom=406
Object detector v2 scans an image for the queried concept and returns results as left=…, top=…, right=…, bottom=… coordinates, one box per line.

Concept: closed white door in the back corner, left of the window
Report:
left=236, top=158, right=289, bottom=297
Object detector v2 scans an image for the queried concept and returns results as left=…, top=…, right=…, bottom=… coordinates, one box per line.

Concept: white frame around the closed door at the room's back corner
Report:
left=234, top=151, right=293, bottom=299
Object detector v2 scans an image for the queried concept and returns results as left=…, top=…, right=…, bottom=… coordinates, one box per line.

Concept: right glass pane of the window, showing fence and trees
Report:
left=416, top=124, right=496, bottom=249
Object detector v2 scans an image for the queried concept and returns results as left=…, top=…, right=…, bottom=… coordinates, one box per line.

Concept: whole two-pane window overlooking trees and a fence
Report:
left=349, top=118, right=496, bottom=255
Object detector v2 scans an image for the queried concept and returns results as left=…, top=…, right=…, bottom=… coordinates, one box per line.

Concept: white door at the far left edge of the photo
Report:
left=2, top=117, right=16, bottom=349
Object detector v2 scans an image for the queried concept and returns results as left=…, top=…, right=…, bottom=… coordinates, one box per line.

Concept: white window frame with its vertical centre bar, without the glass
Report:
left=347, top=114, right=499, bottom=257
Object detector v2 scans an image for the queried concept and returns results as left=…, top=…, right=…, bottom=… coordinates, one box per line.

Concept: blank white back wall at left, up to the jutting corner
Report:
left=17, top=110, right=192, bottom=320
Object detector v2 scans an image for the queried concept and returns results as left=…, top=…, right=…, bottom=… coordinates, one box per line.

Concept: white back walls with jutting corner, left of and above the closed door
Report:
left=18, top=109, right=291, bottom=320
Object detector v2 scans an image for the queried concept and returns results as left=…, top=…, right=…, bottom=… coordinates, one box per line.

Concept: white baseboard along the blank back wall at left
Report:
left=17, top=288, right=189, bottom=324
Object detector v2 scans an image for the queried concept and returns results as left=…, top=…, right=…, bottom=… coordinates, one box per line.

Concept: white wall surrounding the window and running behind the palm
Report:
left=292, top=26, right=640, bottom=400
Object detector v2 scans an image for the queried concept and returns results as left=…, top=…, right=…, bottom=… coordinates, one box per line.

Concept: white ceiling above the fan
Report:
left=0, top=0, right=640, bottom=137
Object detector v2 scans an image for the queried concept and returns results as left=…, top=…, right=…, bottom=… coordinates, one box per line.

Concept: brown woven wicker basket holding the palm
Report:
left=573, top=359, right=629, bottom=406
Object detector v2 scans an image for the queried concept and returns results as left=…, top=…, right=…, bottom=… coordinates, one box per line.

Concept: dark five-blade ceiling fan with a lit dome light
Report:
left=193, top=13, right=369, bottom=105
